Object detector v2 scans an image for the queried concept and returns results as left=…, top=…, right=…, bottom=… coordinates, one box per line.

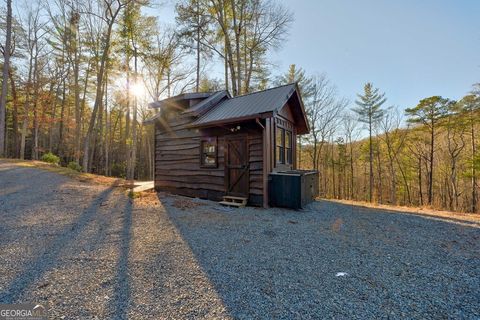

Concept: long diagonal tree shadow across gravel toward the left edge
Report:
left=0, top=186, right=116, bottom=303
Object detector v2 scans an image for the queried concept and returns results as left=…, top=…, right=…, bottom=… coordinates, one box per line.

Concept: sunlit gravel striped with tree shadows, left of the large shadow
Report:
left=0, top=161, right=227, bottom=319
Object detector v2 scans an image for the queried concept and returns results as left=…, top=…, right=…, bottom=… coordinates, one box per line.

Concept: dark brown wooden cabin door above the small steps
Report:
left=225, top=136, right=249, bottom=198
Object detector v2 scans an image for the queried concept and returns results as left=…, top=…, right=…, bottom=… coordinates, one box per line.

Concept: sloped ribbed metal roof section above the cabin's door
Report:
left=192, top=83, right=296, bottom=126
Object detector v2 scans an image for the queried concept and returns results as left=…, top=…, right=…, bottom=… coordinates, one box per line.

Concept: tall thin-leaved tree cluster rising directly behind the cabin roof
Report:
left=186, top=0, right=293, bottom=95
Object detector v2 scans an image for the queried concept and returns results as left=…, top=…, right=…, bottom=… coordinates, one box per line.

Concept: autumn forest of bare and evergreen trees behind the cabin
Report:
left=0, top=0, right=480, bottom=213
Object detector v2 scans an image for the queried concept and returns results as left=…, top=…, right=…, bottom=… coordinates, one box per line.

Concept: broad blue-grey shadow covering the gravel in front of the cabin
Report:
left=158, top=195, right=480, bottom=319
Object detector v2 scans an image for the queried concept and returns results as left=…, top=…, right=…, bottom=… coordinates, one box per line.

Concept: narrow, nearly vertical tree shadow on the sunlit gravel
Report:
left=109, top=199, right=133, bottom=319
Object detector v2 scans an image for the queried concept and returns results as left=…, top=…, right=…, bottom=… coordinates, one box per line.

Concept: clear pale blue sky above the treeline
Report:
left=150, top=0, right=480, bottom=109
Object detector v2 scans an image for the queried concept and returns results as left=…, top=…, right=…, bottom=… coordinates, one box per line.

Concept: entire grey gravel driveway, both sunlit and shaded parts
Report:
left=0, top=161, right=480, bottom=319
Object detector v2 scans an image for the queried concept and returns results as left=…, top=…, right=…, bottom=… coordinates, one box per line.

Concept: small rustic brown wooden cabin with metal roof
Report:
left=147, top=84, right=309, bottom=207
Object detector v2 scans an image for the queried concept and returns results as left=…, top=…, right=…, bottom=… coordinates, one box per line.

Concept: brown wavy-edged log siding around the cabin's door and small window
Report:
left=155, top=116, right=264, bottom=206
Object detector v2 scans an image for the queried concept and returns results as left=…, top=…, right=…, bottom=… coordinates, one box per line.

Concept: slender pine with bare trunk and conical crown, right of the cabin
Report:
left=352, top=82, right=387, bottom=202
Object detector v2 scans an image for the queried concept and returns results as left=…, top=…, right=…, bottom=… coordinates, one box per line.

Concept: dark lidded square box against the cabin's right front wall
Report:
left=268, top=170, right=318, bottom=209
